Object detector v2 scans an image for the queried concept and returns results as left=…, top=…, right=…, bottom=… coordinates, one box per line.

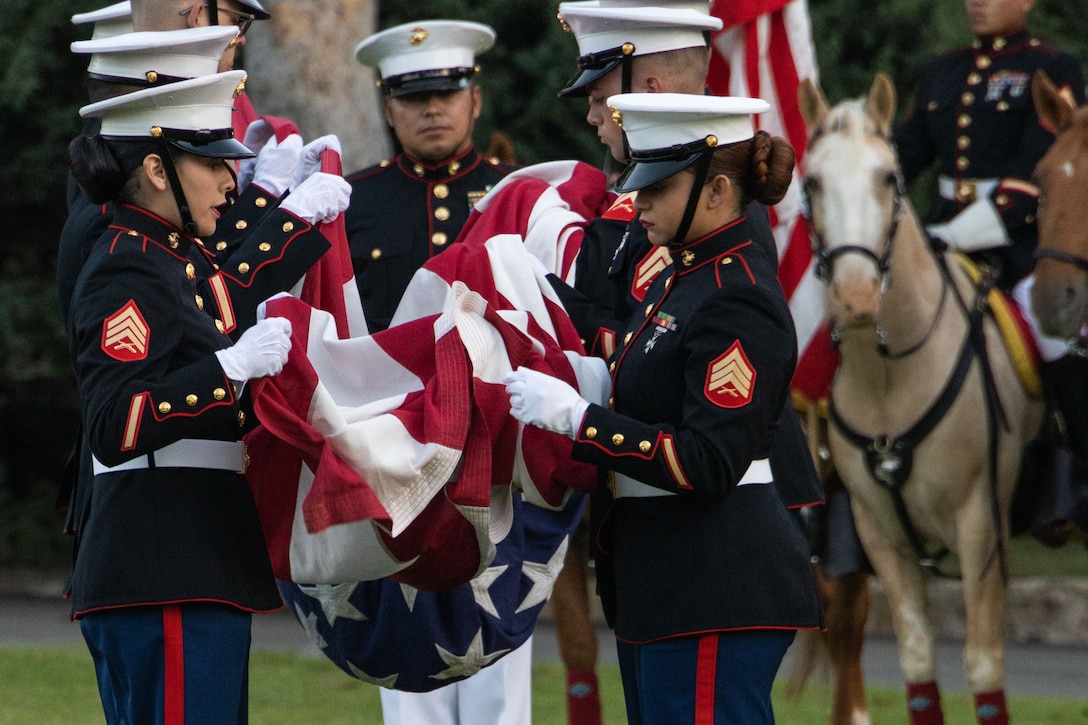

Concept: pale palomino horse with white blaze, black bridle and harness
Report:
left=800, top=75, right=1042, bottom=723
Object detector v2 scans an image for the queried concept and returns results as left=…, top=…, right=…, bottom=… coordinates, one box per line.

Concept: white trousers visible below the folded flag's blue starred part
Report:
left=381, top=637, right=533, bottom=725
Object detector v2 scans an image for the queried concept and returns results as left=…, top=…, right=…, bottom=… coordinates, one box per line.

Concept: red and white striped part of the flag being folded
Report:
left=248, top=156, right=610, bottom=591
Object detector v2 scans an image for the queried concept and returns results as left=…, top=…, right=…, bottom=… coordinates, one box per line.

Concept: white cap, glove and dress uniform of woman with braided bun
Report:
left=507, top=94, right=823, bottom=723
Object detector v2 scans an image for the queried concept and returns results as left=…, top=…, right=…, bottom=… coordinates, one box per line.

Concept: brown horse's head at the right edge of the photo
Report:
left=1031, top=71, right=1088, bottom=337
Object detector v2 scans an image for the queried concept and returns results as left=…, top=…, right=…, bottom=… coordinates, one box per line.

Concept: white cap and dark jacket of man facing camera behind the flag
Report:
left=344, top=21, right=515, bottom=332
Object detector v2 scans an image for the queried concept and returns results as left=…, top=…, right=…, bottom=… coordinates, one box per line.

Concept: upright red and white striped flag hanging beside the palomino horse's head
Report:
left=707, top=0, right=838, bottom=405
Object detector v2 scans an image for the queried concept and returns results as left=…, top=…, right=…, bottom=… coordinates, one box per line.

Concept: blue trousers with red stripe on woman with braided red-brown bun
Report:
left=616, top=629, right=794, bottom=725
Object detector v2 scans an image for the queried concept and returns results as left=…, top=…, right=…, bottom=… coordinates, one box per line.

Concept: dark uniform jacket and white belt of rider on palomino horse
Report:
left=894, top=29, right=1085, bottom=290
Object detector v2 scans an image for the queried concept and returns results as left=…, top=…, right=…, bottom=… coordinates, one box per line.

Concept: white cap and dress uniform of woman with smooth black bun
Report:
left=67, top=71, right=281, bottom=724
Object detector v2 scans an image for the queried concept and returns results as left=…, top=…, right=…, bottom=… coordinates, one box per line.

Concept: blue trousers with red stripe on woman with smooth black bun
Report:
left=79, top=603, right=252, bottom=725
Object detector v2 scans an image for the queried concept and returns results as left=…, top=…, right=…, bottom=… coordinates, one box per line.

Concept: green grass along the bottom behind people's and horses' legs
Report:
left=0, top=646, right=1088, bottom=725
